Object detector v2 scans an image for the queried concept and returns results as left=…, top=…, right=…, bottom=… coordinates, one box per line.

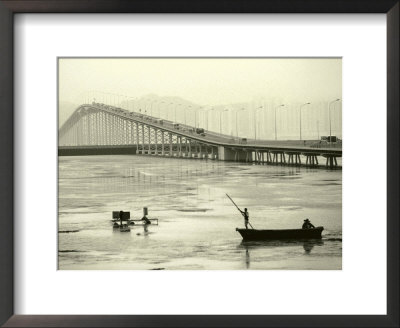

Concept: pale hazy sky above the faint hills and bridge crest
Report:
left=59, top=58, right=342, bottom=105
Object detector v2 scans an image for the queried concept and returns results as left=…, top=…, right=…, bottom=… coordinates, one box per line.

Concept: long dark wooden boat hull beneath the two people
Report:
left=236, top=227, right=324, bottom=240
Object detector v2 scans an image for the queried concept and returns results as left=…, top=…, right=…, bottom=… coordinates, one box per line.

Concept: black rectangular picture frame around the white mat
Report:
left=0, top=0, right=400, bottom=327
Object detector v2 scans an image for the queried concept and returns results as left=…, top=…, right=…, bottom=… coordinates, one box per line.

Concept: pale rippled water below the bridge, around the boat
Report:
left=58, top=155, right=342, bottom=270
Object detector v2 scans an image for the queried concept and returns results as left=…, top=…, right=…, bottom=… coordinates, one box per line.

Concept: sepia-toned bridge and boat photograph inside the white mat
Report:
left=57, top=57, right=343, bottom=270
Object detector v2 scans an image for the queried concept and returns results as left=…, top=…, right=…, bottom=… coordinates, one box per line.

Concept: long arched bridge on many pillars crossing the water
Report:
left=59, top=102, right=342, bottom=168
